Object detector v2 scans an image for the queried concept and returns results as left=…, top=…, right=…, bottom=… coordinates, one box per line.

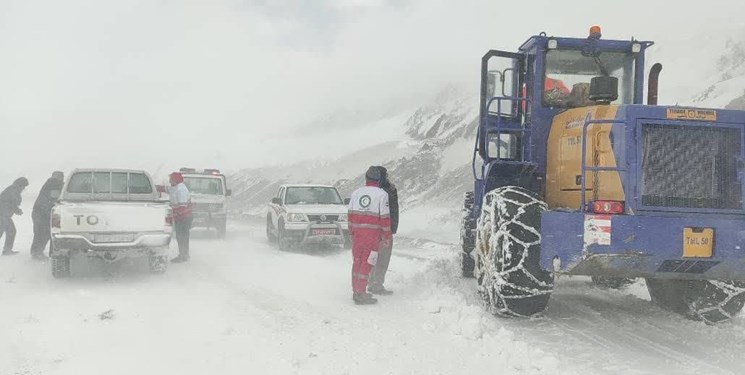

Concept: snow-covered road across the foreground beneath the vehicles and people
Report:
left=0, top=216, right=745, bottom=375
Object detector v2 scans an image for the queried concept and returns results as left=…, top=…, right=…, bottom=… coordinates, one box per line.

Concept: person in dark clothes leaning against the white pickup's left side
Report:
left=31, top=171, right=65, bottom=260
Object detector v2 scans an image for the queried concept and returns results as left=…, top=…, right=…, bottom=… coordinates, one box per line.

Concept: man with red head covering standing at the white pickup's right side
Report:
left=168, top=172, right=193, bottom=263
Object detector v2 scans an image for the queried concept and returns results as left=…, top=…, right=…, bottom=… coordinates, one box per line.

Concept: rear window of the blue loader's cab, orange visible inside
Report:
left=543, top=50, right=634, bottom=108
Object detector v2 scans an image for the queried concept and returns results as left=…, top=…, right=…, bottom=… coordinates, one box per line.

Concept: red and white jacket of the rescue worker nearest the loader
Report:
left=349, top=182, right=392, bottom=251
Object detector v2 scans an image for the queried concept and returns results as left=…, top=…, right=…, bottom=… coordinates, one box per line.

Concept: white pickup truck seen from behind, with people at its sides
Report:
left=49, top=169, right=172, bottom=278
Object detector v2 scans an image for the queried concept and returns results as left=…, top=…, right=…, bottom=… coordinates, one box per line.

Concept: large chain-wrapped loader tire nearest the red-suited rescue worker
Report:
left=475, top=186, right=554, bottom=317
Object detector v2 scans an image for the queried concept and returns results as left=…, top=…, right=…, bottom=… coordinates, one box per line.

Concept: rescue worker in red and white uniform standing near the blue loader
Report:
left=349, top=166, right=392, bottom=305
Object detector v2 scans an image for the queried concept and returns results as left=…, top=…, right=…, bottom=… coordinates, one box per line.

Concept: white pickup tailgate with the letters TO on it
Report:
left=56, top=202, right=170, bottom=233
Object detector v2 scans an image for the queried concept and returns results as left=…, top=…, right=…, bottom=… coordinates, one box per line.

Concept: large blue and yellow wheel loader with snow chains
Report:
left=461, top=27, right=745, bottom=323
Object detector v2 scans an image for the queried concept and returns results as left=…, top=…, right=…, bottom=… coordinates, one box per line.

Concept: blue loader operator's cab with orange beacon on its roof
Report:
left=474, top=27, right=653, bottom=170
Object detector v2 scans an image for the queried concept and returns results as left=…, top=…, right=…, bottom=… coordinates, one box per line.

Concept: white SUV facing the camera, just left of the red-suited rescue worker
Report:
left=266, top=185, right=349, bottom=249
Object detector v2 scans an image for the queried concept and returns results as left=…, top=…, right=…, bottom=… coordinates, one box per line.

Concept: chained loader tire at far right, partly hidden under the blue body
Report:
left=646, top=279, right=745, bottom=324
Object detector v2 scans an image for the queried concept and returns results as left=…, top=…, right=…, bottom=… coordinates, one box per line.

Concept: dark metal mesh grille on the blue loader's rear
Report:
left=642, top=124, right=742, bottom=209
